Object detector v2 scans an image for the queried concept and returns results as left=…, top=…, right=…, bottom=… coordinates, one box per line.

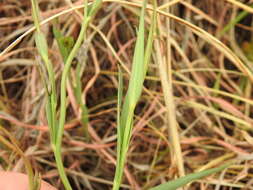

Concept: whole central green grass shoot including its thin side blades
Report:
left=113, top=0, right=156, bottom=190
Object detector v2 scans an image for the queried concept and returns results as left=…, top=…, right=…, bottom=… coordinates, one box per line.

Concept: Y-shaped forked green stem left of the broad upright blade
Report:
left=32, top=0, right=102, bottom=190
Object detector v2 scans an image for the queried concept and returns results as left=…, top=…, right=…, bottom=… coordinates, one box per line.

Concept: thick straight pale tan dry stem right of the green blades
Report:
left=155, top=39, right=184, bottom=176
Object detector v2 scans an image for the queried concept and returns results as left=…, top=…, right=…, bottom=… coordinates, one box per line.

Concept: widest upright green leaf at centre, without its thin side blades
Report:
left=113, top=0, right=147, bottom=190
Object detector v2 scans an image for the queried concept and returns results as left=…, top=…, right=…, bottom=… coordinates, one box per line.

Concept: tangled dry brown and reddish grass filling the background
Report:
left=0, top=0, right=253, bottom=190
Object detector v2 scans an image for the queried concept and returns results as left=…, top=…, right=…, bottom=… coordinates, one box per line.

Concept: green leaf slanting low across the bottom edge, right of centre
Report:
left=150, top=163, right=230, bottom=190
